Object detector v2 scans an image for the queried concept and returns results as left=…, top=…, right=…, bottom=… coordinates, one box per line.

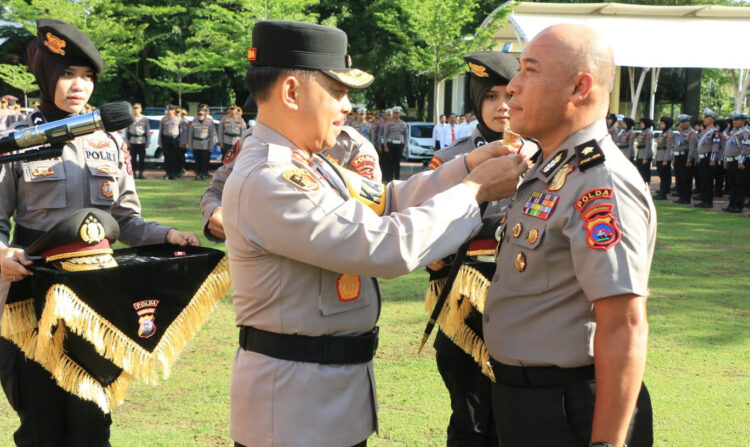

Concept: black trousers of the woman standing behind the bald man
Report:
left=435, top=331, right=497, bottom=447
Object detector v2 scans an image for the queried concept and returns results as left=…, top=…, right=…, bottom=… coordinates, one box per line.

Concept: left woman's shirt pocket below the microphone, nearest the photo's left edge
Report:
left=23, top=159, right=67, bottom=210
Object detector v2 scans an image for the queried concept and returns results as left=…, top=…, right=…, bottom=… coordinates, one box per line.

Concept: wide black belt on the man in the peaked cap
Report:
left=240, top=326, right=378, bottom=365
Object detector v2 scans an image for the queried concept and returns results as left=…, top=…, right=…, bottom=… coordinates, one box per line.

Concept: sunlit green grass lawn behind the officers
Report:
left=0, top=180, right=750, bottom=447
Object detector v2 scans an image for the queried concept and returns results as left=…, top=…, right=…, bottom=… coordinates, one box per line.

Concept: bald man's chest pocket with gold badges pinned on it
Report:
left=497, top=217, right=549, bottom=293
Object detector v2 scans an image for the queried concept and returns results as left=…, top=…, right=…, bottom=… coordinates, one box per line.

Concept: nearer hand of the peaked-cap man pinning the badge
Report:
left=463, top=151, right=529, bottom=203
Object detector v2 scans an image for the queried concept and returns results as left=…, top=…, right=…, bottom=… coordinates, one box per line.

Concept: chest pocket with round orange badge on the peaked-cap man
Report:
left=318, top=270, right=374, bottom=316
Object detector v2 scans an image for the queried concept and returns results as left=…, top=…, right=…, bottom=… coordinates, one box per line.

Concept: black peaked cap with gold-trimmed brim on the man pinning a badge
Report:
left=247, top=20, right=374, bottom=88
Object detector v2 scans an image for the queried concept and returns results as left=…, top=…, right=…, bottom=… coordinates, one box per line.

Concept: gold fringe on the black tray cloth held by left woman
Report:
left=2, top=256, right=230, bottom=413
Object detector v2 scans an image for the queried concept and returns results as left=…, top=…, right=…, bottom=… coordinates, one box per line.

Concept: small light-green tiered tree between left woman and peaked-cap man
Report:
left=146, top=50, right=213, bottom=107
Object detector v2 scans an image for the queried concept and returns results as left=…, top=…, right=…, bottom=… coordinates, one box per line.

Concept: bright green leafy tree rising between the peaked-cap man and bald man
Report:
left=375, top=0, right=512, bottom=121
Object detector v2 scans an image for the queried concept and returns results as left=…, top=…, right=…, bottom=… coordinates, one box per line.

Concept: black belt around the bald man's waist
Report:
left=490, top=358, right=594, bottom=388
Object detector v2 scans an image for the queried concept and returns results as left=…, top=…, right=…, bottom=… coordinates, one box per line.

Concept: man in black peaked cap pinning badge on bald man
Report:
left=222, top=21, right=525, bottom=447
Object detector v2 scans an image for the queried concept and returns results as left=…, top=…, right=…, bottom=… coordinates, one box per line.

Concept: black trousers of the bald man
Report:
left=492, top=380, right=654, bottom=447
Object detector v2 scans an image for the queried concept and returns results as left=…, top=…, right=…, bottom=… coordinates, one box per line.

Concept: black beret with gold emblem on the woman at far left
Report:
left=36, top=19, right=104, bottom=73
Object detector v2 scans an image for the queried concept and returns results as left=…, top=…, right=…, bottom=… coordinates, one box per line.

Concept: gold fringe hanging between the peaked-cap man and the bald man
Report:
left=425, top=265, right=495, bottom=381
